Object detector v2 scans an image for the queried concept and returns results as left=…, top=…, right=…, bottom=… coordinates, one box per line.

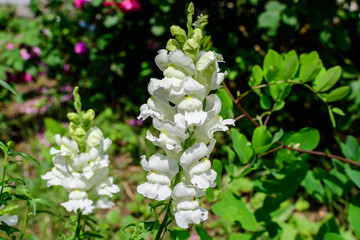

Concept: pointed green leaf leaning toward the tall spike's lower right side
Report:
left=231, top=128, right=254, bottom=164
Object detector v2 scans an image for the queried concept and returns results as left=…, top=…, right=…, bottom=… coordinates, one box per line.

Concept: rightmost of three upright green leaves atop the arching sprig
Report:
left=299, top=51, right=322, bottom=82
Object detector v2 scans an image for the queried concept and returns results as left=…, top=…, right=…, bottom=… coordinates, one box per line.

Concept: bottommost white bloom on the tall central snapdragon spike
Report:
left=171, top=182, right=208, bottom=228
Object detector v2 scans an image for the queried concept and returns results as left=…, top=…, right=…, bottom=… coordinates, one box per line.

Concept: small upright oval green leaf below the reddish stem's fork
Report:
left=252, top=126, right=273, bottom=154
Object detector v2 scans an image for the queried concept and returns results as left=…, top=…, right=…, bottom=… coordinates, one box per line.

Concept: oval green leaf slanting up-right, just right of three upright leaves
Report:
left=313, top=66, right=341, bottom=92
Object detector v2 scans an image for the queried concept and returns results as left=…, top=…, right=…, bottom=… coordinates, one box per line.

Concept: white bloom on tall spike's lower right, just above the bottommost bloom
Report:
left=180, top=140, right=216, bottom=189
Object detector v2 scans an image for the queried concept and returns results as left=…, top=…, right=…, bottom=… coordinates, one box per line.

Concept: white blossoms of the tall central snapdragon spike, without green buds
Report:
left=137, top=50, right=234, bottom=228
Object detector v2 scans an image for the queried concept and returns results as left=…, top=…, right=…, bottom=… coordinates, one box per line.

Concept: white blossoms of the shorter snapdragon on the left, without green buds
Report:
left=41, top=127, right=120, bottom=215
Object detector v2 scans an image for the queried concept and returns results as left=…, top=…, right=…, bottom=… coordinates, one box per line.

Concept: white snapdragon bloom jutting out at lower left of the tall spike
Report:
left=137, top=153, right=179, bottom=201
